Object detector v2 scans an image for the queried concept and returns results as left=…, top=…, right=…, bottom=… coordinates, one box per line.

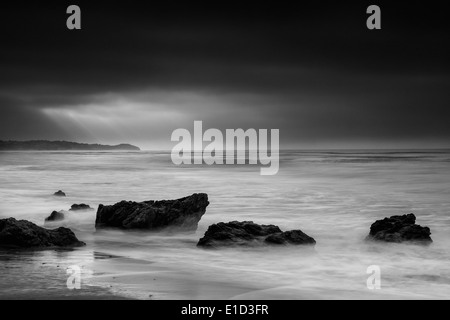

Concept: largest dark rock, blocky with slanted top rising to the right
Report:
left=95, top=193, right=209, bottom=231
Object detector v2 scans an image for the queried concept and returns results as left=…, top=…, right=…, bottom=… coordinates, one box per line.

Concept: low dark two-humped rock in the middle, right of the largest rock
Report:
left=197, top=221, right=316, bottom=248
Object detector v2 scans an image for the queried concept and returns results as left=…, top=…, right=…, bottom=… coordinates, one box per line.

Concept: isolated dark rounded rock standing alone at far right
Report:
left=366, top=213, right=433, bottom=244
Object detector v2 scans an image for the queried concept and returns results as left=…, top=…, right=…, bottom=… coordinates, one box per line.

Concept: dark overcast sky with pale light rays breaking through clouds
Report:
left=0, top=1, right=450, bottom=149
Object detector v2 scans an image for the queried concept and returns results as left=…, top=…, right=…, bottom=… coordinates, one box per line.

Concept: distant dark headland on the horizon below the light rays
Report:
left=0, top=140, right=141, bottom=151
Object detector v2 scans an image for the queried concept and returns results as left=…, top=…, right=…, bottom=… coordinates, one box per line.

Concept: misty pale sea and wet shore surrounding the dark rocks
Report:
left=0, top=150, right=450, bottom=299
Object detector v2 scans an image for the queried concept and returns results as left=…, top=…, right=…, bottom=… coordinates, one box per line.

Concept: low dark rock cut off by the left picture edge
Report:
left=0, top=218, right=86, bottom=248
